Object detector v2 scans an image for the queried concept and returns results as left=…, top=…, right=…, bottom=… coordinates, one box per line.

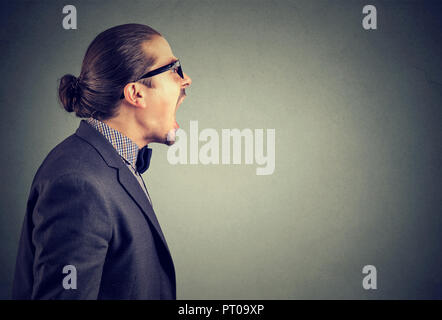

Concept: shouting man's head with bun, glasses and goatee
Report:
left=59, top=24, right=191, bottom=147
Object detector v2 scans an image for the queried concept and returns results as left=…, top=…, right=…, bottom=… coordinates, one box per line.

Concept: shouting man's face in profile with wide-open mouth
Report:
left=138, top=36, right=192, bottom=145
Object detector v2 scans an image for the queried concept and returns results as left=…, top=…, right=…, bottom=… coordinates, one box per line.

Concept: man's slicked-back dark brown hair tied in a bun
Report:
left=58, top=24, right=161, bottom=120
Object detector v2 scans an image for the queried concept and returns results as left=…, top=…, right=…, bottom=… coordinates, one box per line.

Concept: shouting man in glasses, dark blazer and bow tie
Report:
left=13, top=24, right=191, bottom=299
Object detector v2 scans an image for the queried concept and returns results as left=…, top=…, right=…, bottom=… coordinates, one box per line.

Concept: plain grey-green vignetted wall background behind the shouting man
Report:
left=0, top=0, right=442, bottom=299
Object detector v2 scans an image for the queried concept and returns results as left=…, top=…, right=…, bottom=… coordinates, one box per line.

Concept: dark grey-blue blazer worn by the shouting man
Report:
left=12, top=120, right=176, bottom=299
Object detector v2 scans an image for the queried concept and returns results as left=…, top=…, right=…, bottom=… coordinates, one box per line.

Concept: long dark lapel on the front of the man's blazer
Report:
left=75, top=120, right=172, bottom=258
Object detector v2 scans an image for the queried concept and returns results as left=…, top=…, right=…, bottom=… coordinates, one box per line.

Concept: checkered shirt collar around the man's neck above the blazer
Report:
left=86, top=118, right=139, bottom=170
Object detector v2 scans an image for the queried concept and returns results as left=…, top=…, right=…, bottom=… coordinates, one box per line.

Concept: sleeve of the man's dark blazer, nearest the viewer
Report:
left=31, top=174, right=112, bottom=299
